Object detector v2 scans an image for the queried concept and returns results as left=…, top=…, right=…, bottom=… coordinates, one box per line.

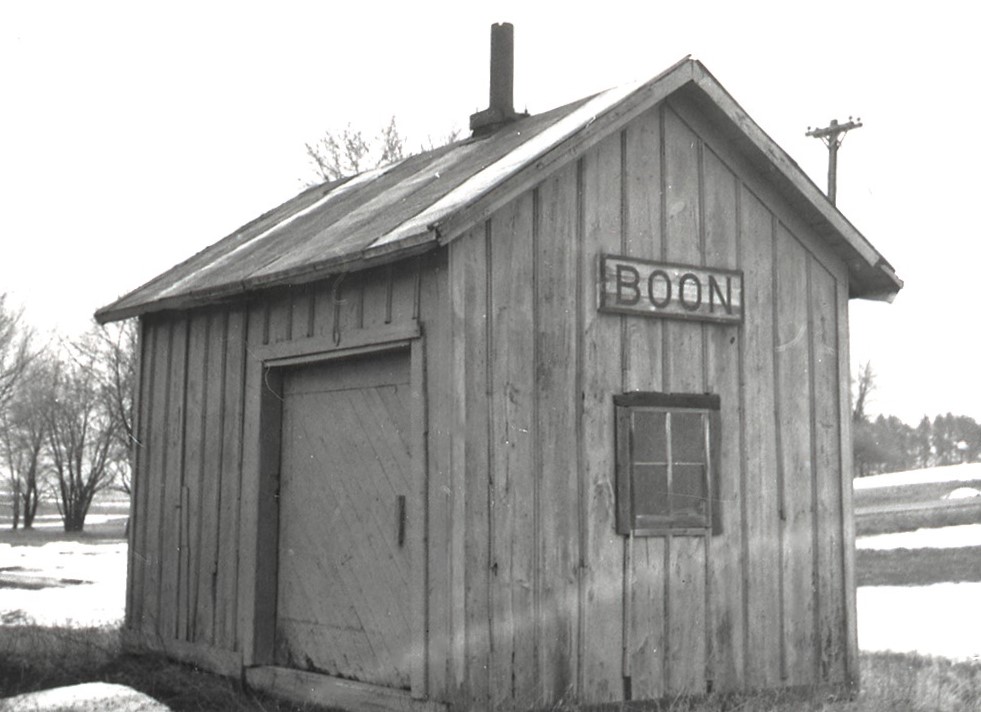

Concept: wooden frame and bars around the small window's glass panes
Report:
left=613, top=391, right=722, bottom=536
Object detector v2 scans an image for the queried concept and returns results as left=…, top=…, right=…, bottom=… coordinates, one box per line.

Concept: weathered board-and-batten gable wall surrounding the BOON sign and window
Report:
left=446, top=100, right=857, bottom=709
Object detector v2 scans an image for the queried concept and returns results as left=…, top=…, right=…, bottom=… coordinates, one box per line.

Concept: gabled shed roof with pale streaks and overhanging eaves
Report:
left=96, top=58, right=902, bottom=323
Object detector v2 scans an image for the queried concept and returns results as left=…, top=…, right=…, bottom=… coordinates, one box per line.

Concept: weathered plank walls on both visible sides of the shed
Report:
left=126, top=90, right=857, bottom=709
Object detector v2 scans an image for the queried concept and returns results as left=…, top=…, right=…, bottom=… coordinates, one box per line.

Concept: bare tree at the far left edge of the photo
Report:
left=0, top=359, right=53, bottom=529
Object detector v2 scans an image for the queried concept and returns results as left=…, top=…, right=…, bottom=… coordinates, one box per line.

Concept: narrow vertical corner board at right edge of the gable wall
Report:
left=836, top=277, right=859, bottom=689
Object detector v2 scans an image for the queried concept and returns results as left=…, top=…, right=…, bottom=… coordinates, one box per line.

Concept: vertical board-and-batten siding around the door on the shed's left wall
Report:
left=125, top=252, right=447, bottom=675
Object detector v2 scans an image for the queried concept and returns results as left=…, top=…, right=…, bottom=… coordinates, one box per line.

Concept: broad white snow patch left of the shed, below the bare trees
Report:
left=0, top=541, right=126, bottom=627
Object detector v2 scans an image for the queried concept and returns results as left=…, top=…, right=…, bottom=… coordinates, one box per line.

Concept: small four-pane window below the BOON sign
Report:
left=613, top=393, right=719, bottom=536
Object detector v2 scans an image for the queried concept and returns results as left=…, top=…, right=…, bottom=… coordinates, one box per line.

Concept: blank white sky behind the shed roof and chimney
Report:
left=0, top=0, right=981, bottom=424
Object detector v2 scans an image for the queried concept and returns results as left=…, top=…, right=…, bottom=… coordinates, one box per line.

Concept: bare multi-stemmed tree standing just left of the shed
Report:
left=46, top=346, right=127, bottom=532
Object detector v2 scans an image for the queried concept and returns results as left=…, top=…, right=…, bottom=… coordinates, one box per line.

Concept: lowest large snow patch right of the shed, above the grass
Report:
left=857, top=582, right=981, bottom=660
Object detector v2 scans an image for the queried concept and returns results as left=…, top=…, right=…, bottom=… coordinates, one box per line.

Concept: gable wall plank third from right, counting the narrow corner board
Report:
left=774, top=225, right=816, bottom=685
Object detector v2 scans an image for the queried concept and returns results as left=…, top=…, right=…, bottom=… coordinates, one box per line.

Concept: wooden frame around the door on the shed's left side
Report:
left=238, top=321, right=430, bottom=699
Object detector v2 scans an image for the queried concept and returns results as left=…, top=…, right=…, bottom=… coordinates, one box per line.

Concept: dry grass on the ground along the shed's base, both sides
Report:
left=0, top=626, right=981, bottom=712
